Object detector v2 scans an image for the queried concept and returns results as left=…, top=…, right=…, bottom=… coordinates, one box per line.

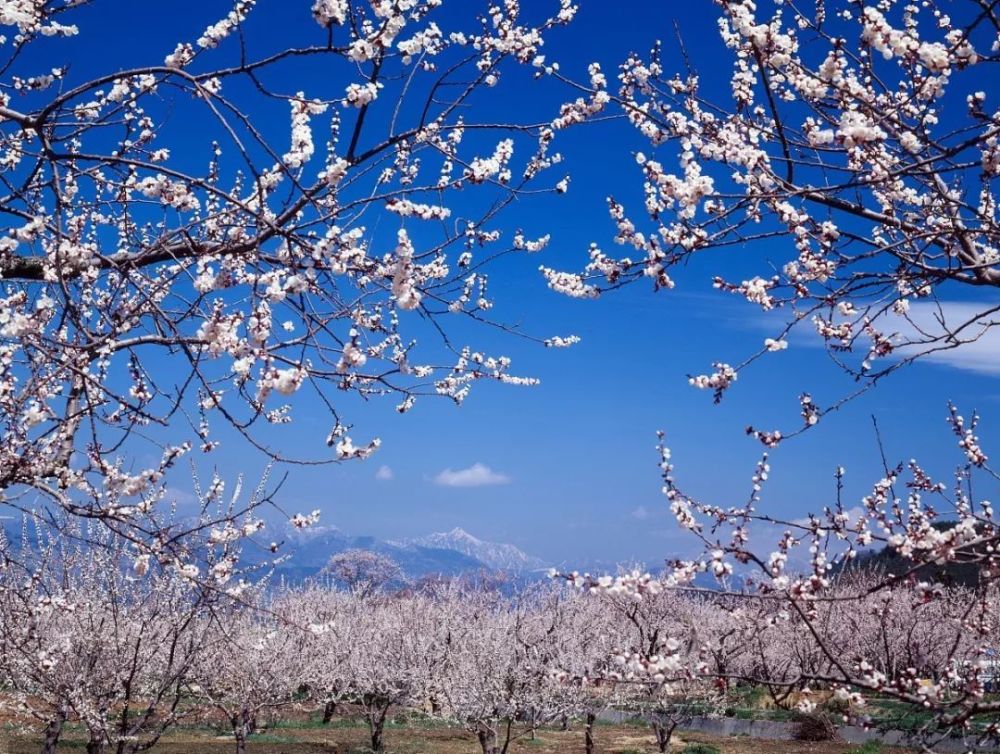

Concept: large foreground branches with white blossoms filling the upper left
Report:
left=0, top=0, right=575, bottom=540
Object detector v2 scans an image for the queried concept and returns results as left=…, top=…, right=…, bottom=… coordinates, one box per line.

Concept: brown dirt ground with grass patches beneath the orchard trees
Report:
left=0, top=721, right=905, bottom=754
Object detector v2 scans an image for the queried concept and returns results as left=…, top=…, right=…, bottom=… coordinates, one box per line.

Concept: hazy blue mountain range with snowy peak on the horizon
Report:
left=277, top=526, right=547, bottom=581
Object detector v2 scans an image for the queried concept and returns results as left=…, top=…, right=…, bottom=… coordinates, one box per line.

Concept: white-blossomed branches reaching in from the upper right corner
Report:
left=542, top=0, right=1000, bottom=438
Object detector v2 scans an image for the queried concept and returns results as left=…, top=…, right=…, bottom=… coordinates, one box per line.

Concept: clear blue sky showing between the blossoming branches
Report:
left=25, top=0, right=1000, bottom=566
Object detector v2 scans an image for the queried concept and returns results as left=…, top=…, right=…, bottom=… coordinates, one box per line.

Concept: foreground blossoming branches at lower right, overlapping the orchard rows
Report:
left=569, top=424, right=1000, bottom=741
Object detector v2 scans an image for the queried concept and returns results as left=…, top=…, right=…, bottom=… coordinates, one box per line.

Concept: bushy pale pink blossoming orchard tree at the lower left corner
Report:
left=0, top=528, right=212, bottom=754
